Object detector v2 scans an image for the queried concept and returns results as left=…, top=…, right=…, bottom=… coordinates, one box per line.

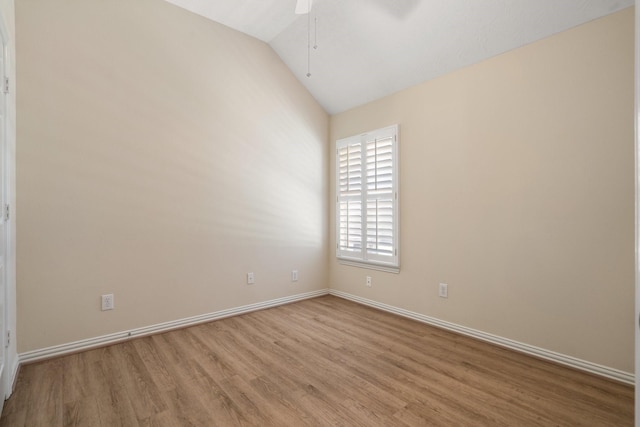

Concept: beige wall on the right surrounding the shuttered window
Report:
left=330, top=9, right=634, bottom=372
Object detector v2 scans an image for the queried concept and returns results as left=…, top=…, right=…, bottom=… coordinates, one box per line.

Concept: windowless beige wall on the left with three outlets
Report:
left=16, top=0, right=329, bottom=352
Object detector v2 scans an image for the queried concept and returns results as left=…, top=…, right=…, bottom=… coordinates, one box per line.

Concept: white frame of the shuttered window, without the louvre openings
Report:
left=335, top=124, right=400, bottom=273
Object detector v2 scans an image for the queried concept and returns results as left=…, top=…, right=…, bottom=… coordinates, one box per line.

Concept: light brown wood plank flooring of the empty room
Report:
left=0, top=296, right=633, bottom=427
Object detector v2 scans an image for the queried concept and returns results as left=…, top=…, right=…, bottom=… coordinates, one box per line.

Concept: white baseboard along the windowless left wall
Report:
left=20, top=289, right=329, bottom=366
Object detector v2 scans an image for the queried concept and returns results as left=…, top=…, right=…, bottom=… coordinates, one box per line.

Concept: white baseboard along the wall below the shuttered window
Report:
left=329, top=289, right=635, bottom=385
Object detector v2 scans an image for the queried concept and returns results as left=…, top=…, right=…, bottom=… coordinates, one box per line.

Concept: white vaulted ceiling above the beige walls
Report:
left=162, top=0, right=634, bottom=114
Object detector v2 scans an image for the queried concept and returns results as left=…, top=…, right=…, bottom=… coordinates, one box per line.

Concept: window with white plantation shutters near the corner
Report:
left=336, top=125, right=399, bottom=272
